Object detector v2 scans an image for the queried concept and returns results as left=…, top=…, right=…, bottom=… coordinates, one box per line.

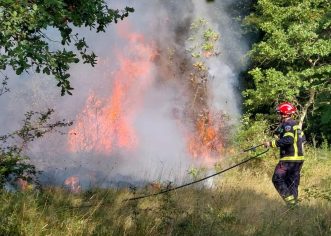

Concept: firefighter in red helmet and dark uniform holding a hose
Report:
left=264, top=102, right=304, bottom=207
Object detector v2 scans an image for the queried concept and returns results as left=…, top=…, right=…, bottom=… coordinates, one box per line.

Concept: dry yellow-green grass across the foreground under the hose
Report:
left=0, top=150, right=331, bottom=235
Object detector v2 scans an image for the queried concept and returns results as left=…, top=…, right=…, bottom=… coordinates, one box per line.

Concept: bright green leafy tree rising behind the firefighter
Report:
left=243, top=0, right=331, bottom=140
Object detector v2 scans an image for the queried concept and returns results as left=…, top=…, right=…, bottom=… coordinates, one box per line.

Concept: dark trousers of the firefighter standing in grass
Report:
left=272, top=161, right=303, bottom=199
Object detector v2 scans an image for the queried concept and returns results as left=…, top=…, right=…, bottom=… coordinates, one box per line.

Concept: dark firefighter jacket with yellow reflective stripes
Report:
left=271, top=119, right=304, bottom=161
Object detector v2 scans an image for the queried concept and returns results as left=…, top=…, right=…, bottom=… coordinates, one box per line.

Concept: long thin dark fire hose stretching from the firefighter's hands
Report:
left=124, top=144, right=269, bottom=201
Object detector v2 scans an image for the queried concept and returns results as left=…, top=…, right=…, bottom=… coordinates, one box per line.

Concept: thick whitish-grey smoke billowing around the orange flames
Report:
left=0, top=0, right=246, bottom=186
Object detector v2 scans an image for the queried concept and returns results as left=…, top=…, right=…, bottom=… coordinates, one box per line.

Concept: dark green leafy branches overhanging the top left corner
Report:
left=0, top=0, right=134, bottom=95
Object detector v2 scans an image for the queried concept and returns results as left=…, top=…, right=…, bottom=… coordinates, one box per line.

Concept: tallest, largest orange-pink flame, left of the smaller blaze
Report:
left=68, top=25, right=155, bottom=153
